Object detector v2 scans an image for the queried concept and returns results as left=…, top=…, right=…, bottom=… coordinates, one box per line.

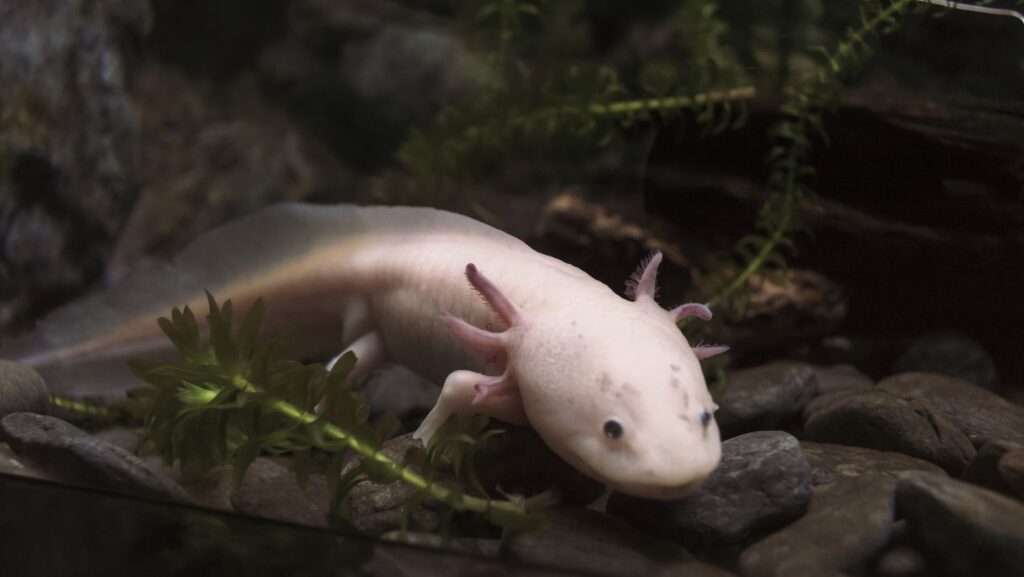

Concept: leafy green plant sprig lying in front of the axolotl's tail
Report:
left=130, top=296, right=546, bottom=528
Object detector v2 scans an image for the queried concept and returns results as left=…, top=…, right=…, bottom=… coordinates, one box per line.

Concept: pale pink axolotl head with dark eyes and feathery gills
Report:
left=448, top=253, right=725, bottom=499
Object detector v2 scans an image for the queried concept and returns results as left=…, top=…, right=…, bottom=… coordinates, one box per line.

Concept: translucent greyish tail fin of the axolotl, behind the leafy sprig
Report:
left=0, top=204, right=361, bottom=399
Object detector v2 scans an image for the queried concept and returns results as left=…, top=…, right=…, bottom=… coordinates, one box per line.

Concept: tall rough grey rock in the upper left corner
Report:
left=0, top=0, right=150, bottom=326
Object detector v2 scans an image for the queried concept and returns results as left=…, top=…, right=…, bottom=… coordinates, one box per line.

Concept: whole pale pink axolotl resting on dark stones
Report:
left=6, top=204, right=724, bottom=499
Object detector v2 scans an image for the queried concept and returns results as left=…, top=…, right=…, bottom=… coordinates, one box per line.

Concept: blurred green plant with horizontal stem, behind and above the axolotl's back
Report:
left=375, top=0, right=755, bottom=204
